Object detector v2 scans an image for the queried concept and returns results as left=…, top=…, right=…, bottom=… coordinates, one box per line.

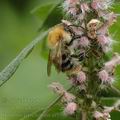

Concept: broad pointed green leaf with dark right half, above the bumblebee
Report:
left=31, top=0, right=62, bottom=30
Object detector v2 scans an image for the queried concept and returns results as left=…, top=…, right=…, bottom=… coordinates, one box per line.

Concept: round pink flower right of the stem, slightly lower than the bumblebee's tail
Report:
left=98, top=70, right=109, bottom=83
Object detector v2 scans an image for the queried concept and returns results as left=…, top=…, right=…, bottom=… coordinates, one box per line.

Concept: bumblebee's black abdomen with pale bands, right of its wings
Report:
left=61, top=54, right=73, bottom=72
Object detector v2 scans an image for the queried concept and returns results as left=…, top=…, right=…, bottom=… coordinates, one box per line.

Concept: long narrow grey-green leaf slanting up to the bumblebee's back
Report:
left=0, top=30, right=49, bottom=86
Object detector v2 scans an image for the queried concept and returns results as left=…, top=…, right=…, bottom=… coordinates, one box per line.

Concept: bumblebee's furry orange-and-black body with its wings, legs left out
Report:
left=47, top=24, right=73, bottom=76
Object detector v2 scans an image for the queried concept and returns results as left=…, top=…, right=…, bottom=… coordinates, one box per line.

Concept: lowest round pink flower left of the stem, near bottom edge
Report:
left=64, top=102, right=77, bottom=115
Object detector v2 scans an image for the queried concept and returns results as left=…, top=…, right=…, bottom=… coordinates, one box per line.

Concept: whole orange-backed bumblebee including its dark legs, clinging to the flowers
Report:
left=47, top=24, right=85, bottom=76
